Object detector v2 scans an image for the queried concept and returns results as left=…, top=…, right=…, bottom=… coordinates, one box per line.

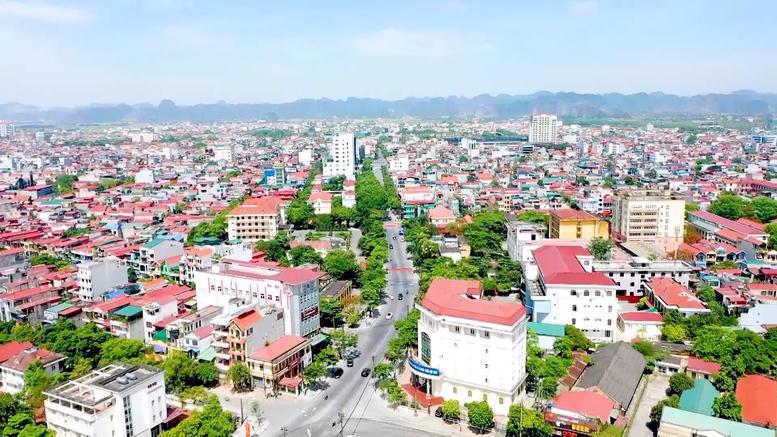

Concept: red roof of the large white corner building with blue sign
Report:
left=421, top=278, right=526, bottom=325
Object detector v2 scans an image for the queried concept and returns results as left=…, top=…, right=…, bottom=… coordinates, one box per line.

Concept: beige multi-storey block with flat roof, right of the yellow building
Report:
left=612, top=191, right=685, bottom=252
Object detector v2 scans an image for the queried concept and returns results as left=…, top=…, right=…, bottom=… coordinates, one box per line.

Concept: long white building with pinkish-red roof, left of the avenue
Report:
left=194, top=260, right=323, bottom=336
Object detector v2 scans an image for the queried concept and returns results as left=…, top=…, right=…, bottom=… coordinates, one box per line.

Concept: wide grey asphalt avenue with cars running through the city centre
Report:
left=272, top=213, right=422, bottom=437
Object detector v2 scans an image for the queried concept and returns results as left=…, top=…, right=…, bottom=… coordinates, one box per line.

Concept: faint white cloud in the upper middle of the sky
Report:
left=353, top=28, right=494, bottom=59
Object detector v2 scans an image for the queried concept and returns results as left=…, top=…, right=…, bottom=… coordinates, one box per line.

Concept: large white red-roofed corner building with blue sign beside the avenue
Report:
left=408, top=279, right=526, bottom=415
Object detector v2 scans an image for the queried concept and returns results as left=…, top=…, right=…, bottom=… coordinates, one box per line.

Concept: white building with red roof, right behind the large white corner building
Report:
left=523, top=245, right=618, bottom=342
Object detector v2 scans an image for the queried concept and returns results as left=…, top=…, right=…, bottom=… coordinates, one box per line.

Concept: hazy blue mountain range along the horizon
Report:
left=0, top=90, right=777, bottom=124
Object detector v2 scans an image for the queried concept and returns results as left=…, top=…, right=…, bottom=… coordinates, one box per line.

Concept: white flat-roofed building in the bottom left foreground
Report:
left=44, top=363, right=167, bottom=437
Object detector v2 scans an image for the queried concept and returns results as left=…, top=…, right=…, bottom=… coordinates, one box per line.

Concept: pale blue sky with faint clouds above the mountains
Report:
left=0, top=0, right=777, bottom=107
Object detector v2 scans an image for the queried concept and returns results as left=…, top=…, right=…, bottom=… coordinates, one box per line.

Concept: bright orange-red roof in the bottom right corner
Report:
left=736, top=375, right=777, bottom=427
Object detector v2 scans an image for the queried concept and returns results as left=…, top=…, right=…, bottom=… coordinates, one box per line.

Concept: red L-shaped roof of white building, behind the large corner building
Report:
left=534, top=246, right=615, bottom=285
